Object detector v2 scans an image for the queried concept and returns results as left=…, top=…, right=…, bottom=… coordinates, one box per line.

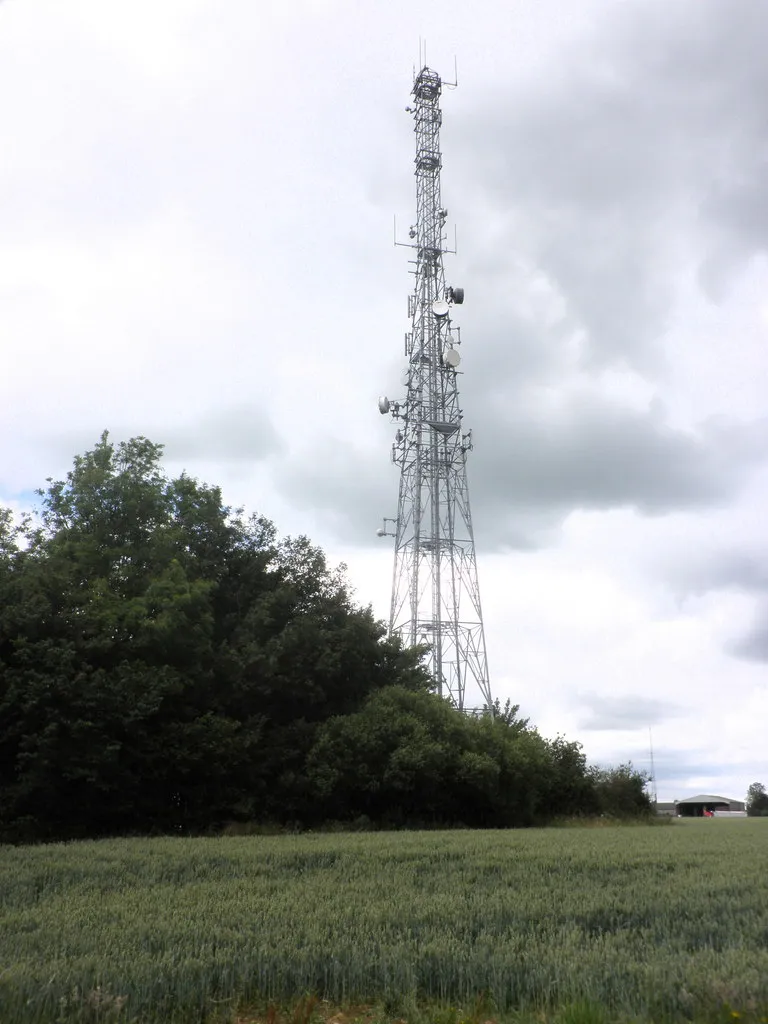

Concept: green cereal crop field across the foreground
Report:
left=0, top=819, right=768, bottom=1024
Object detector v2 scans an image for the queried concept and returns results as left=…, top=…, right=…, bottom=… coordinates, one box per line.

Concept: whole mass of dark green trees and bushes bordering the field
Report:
left=0, top=434, right=649, bottom=840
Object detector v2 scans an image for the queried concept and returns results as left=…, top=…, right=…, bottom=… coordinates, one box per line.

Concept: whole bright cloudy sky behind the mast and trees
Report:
left=0, top=0, right=768, bottom=799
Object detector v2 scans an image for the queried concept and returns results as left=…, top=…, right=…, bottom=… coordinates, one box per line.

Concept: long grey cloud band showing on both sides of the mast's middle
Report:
left=275, top=403, right=768, bottom=551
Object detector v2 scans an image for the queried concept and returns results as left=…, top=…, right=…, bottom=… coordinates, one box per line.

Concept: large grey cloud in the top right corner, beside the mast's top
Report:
left=457, top=0, right=768, bottom=371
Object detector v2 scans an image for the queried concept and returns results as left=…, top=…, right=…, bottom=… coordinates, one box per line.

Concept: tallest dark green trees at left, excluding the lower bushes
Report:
left=0, top=434, right=429, bottom=838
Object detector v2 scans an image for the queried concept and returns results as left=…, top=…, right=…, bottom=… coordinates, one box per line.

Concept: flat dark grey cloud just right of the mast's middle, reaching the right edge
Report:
left=472, top=396, right=768, bottom=544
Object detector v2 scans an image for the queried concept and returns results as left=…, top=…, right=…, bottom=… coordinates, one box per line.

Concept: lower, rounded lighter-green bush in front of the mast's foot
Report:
left=307, top=687, right=589, bottom=827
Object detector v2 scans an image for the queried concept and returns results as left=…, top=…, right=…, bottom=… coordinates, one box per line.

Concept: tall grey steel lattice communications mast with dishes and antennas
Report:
left=378, top=67, right=492, bottom=711
